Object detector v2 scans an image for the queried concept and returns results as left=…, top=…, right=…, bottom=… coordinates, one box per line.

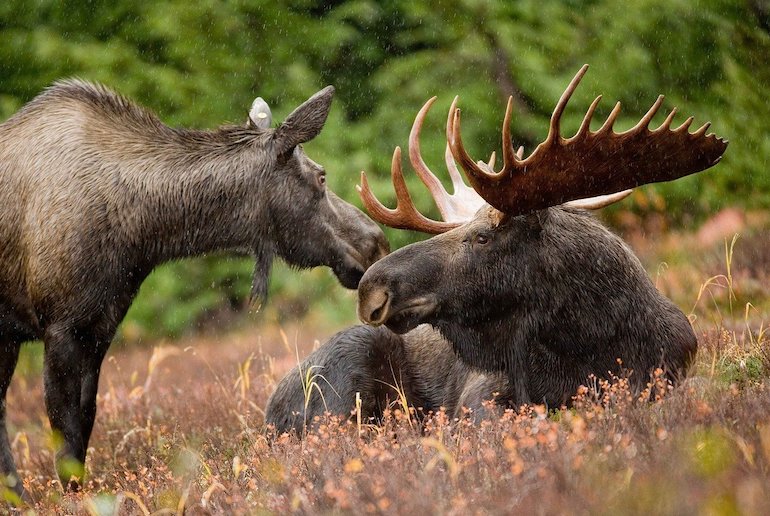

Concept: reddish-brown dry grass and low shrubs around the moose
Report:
left=8, top=223, right=770, bottom=514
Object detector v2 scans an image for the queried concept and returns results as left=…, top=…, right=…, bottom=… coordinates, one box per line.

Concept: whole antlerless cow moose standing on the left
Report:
left=0, top=80, right=389, bottom=493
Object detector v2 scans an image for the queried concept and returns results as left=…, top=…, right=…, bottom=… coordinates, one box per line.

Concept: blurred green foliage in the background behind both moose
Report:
left=0, top=0, right=770, bottom=337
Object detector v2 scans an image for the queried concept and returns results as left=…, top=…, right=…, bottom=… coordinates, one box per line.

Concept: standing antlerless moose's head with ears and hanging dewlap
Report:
left=237, top=86, right=389, bottom=298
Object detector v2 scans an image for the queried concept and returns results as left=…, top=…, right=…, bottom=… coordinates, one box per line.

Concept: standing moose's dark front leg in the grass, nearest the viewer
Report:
left=43, top=327, right=86, bottom=490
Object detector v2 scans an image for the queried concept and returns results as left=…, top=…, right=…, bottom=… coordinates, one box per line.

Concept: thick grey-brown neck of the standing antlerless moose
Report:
left=108, top=130, right=273, bottom=266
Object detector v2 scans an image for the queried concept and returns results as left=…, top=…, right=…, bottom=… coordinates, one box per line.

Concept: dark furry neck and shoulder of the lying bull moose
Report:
left=437, top=211, right=696, bottom=406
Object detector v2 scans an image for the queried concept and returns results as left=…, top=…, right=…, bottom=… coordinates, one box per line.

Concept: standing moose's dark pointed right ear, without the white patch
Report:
left=273, top=86, right=334, bottom=154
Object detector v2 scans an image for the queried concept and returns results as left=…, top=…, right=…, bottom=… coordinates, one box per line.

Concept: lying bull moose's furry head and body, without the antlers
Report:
left=267, top=207, right=697, bottom=431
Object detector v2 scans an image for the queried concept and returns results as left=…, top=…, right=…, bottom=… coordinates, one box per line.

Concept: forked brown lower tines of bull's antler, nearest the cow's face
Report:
left=357, top=147, right=460, bottom=234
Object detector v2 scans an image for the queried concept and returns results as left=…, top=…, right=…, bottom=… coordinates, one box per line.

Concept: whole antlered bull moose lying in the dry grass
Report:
left=266, top=65, right=727, bottom=434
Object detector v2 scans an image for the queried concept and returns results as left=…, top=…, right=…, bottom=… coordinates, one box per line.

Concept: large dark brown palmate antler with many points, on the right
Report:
left=449, top=65, right=728, bottom=215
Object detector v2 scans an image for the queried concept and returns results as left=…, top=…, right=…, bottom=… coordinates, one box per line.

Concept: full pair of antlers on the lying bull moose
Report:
left=357, top=65, right=728, bottom=234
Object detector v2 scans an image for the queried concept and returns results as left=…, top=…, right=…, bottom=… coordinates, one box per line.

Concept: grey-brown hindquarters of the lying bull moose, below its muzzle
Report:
left=265, top=325, right=507, bottom=435
